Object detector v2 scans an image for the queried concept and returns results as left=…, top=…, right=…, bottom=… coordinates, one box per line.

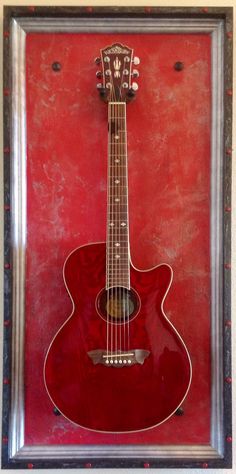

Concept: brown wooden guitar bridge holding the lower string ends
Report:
left=88, top=349, right=150, bottom=367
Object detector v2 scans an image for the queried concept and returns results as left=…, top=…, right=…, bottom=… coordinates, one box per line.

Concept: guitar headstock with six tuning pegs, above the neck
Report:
left=95, top=43, right=140, bottom=102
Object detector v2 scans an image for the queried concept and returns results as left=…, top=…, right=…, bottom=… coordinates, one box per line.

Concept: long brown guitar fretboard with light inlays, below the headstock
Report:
left=106, top=102, right=130, bottom=289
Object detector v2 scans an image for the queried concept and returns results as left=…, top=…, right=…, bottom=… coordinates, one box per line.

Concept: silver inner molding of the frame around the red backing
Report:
left=9, top=16, right=224, bottom=461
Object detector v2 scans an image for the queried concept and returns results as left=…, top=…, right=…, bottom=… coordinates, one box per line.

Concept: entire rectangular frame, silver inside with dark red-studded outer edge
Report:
left=2, top=6, right=233, bottom=469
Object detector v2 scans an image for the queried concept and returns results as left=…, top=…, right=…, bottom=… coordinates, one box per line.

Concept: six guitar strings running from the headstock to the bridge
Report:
left=106, top=72, right=130, bottom=363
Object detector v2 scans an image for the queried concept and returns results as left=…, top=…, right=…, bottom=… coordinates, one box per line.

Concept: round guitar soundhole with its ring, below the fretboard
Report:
left=97, top=287, right=140, bottom=324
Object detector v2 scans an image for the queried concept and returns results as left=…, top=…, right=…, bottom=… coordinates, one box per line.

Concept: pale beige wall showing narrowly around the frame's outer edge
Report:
left=0, top=0, right=236, bottom=474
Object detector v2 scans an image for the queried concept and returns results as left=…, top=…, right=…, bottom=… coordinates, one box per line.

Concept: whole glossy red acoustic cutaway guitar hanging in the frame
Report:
left=44, top=44, right=192, bottom=432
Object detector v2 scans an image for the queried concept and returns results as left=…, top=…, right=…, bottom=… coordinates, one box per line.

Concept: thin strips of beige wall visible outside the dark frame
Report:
left=0, top=0, right=236, bottom=474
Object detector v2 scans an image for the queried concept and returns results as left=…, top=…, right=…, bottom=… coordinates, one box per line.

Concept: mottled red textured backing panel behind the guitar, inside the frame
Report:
left=25, top=34, right=211, bottom=444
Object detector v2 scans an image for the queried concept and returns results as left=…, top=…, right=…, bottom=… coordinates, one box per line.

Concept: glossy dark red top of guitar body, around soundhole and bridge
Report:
left=44, top=243, right=191, bottom=432
